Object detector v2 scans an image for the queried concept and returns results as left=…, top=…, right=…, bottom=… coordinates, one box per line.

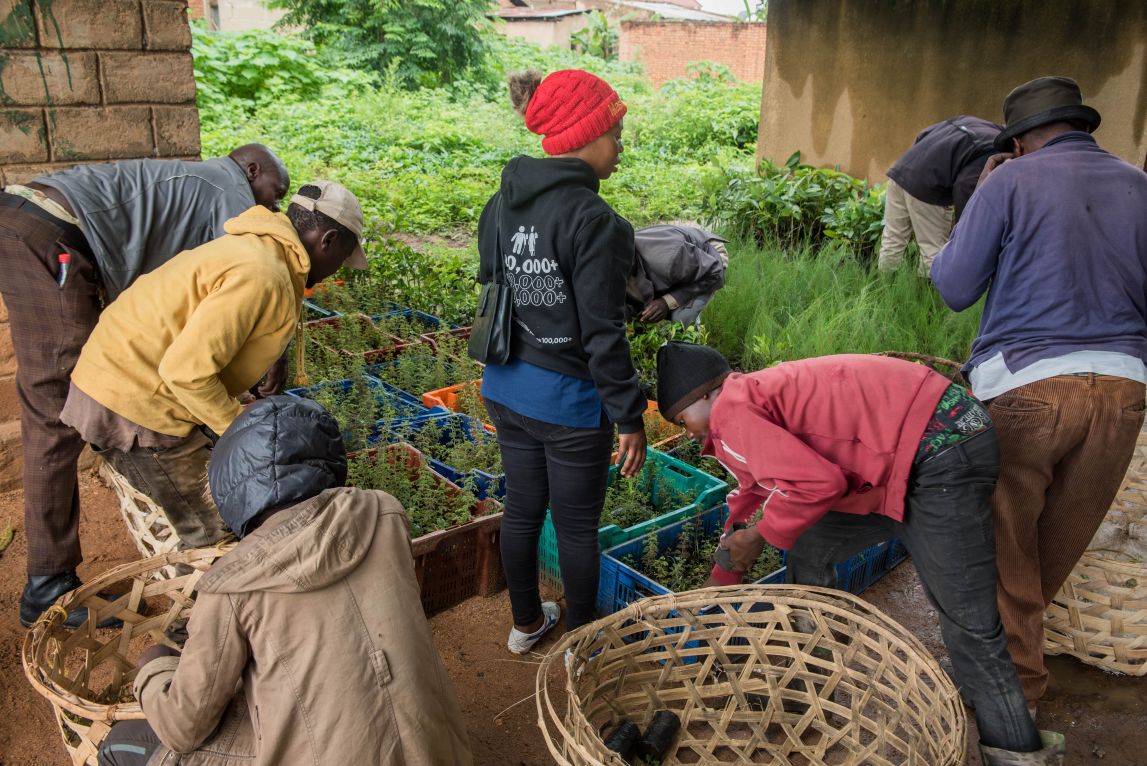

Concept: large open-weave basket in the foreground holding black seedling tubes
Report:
left=537, top=585, right=967, bottom=766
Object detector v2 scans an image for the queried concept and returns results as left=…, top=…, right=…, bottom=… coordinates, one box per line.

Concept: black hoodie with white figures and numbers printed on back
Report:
left=478, top=157, right=646, bottom=433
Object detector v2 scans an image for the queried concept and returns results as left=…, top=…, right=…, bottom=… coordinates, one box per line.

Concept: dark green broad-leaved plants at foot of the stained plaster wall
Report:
left=707, top=153, right=884, bottom=258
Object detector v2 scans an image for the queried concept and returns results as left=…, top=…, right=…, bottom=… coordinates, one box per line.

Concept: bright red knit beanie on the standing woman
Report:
left=525, top=69, right=625, bottom=155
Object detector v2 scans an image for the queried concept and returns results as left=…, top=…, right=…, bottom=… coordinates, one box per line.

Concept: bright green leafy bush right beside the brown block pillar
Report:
left=192, top=22, right=374, bottom=119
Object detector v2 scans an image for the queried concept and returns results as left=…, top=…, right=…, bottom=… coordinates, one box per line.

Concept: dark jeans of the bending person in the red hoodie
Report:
left=787, top=429, right=1041, bottom=752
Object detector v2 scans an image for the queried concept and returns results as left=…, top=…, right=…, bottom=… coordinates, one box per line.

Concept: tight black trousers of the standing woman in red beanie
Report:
left=486, top=399, right=614, bottom=631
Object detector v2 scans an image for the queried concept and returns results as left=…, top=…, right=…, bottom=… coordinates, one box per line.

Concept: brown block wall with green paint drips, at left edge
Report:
left=0, top=0, right=200, bottom=491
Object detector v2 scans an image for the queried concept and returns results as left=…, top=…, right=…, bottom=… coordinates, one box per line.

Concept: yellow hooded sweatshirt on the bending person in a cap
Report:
left=71, top=206, right=311, bottom=436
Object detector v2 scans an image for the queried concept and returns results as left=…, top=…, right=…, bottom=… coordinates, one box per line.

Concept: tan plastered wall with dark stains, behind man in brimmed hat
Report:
left=758, top=0, right=1147, bottom=182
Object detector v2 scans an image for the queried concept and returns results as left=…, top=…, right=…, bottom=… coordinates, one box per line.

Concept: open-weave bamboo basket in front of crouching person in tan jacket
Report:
left=23, top=546, right=232, bottom=766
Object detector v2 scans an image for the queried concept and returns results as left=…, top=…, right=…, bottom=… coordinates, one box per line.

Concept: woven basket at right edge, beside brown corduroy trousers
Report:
left=1044, top=431, right=1147, bottom=675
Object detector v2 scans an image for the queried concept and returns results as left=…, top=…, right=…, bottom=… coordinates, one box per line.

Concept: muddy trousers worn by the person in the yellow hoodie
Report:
left=92, top=429, right=228, bottom=548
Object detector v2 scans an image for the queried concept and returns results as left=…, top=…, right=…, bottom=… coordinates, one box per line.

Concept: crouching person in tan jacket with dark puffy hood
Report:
left=100, top=397, right=473, bottom=766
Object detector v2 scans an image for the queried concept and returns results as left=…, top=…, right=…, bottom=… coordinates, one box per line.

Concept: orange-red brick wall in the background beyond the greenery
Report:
left=618, top=21, right=765, bottom=85
